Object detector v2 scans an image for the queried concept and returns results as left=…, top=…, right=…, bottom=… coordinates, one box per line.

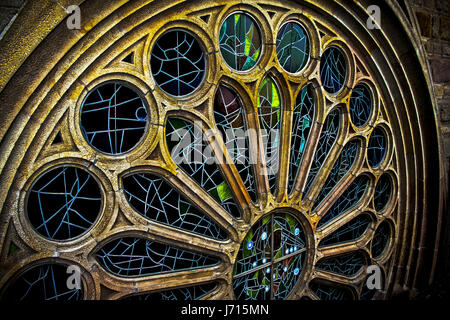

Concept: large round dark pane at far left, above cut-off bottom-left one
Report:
left=26, top=165, right=102, bottom=241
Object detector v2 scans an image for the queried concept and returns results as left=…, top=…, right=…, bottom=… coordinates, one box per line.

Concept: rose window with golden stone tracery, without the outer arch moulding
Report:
left=0, top=0, right=402, bottom=301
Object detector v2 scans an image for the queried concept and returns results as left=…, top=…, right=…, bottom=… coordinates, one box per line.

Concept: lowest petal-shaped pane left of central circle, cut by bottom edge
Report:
left=122, top=283, right=216, bottom=302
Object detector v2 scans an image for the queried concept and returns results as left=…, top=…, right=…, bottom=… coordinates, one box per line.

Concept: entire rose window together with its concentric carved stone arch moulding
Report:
left=0, top=0, right=446, bottom=300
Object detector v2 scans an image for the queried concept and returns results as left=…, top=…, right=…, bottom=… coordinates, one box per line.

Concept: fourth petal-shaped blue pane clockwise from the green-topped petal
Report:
left=317, top=175, right=370, bottom=227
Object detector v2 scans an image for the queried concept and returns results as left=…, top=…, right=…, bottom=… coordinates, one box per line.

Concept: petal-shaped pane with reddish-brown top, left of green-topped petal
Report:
left=214, top=85, right=257, bottom=201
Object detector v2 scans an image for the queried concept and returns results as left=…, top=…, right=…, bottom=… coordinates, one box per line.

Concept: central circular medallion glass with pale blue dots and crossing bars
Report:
left=233, top=212, right=307, bottom=300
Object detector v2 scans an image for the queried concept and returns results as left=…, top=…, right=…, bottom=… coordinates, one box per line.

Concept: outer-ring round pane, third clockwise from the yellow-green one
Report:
left=350, top=83, right=373, bottom=127
